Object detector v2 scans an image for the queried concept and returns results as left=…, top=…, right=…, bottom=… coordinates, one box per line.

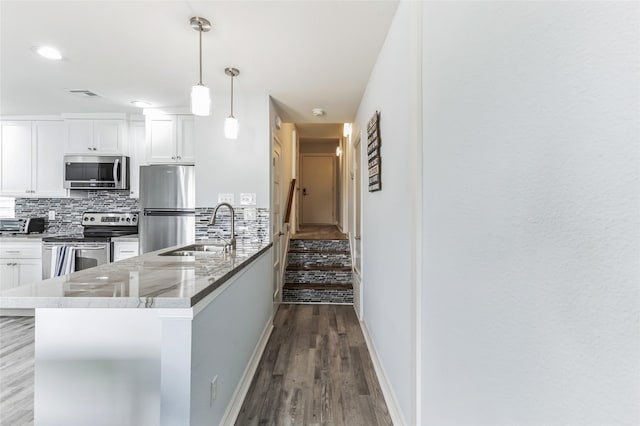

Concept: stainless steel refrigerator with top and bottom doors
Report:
left=139, top=164, right=196, bottom=253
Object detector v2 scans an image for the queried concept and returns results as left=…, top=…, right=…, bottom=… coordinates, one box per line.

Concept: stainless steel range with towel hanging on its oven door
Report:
left=42, top=212, right=138, bottom=279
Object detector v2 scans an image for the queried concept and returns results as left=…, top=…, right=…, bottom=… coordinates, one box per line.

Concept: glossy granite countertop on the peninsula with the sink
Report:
left=0, top=241, right=271, bottom=309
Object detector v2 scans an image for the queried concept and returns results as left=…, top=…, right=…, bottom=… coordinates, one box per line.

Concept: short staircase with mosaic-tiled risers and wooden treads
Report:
left=282, top=239, right=353, bottom=304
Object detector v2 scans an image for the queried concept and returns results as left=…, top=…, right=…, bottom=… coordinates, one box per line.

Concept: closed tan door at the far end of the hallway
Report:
left=300, top=154, right=336, bottom=225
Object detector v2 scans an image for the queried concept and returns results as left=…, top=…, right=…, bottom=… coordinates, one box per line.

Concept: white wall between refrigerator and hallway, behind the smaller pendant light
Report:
left=195, top=93, right=271, bottom=207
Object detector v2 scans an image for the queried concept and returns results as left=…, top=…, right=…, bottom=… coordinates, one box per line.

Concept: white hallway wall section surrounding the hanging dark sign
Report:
left=354, top=0, right=418, bottom=424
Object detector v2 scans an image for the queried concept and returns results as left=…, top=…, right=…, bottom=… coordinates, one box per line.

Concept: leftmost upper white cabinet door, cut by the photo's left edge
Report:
left=0, top=121, right=33, bottom=197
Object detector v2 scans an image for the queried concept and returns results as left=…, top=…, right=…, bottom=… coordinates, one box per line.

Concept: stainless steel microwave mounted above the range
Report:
left=64, top=155, right=129, bottom=189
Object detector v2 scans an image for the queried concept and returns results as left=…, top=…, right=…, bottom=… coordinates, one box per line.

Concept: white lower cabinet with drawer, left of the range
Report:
left=0, top=240, right=42, bottom=290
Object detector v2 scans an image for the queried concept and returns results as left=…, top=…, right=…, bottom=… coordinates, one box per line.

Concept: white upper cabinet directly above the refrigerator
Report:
left=146, top=114, right=195, bottom=164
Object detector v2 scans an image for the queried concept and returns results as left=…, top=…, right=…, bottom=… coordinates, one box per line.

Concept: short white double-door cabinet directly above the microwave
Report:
left=65, top=119, right=126, bottom=154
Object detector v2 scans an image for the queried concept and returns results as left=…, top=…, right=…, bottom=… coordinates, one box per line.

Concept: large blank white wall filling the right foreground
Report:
left=422, top=2, right=640, bottom=426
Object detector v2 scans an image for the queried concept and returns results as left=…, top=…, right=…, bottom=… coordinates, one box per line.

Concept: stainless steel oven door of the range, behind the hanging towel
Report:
left=42, top=242, right=111, bottom=280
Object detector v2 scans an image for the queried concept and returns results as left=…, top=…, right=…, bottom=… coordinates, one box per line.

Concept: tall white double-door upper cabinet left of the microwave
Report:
left=0, top=121, right=67, bottom=197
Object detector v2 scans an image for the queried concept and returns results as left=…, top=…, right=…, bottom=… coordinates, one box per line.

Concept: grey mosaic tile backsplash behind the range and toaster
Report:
left=16, top=191, right=139, bottom=235
